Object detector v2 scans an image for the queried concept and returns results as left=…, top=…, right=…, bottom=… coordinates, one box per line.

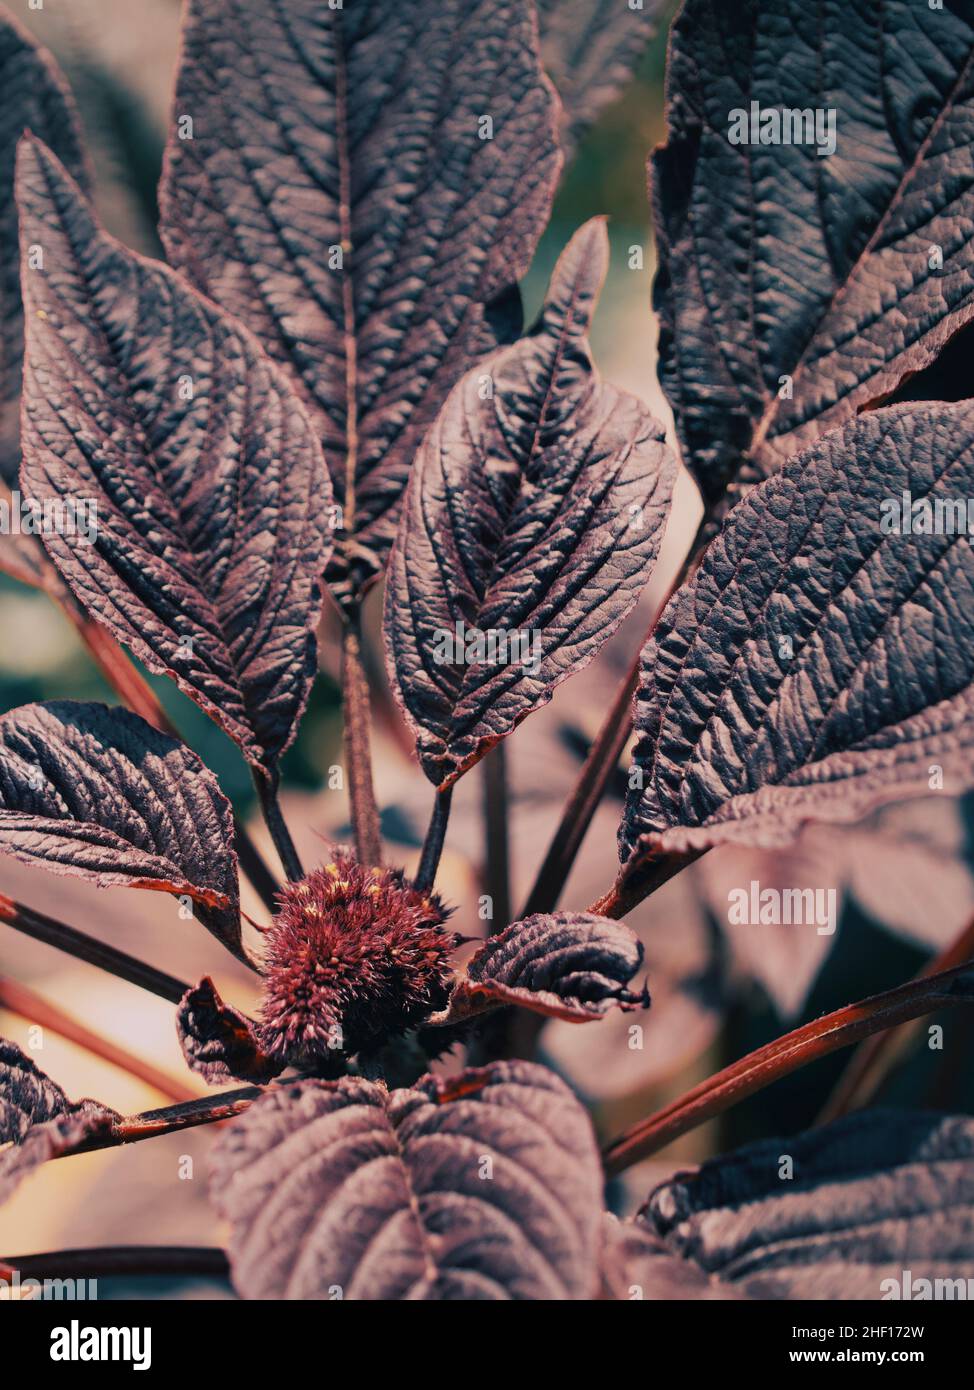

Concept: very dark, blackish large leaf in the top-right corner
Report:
left=653, top=0, right=974, bottom=500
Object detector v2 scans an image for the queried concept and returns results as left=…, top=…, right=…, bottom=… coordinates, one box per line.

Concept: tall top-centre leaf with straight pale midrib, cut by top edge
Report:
left=160, top=0, right=560, bottom=596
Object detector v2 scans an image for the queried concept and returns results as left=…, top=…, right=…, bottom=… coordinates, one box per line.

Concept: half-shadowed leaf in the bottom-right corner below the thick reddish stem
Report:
left=636, top=1111, right=974, bottom=1300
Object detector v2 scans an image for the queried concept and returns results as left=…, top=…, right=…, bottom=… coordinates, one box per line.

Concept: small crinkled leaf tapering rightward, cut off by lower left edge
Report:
left=0, top=1038, right=117, bottom=1202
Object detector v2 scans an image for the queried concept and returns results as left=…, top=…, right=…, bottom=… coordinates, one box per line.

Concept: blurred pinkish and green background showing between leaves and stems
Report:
left=0, top=0, right=974, bottom=1297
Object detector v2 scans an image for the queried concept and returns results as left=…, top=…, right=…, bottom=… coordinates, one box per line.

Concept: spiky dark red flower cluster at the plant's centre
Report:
left=261, top=855, right=456, bottom=1069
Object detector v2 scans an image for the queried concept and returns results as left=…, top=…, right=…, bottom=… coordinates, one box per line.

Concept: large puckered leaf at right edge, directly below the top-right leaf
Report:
left=620, top=403, right=974, bottom=858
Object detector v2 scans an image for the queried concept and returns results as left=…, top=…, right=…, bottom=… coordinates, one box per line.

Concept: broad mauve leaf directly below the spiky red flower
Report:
left=211, top=1062, right=602, bottom=1301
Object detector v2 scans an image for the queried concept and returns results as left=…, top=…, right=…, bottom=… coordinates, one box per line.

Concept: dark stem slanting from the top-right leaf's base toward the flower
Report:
left=521, top=512, right=711, bottom=917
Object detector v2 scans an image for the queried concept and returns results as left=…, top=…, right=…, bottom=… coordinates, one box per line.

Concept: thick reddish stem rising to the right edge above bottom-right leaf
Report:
left=603, top=965, right=974, bottom=1176
